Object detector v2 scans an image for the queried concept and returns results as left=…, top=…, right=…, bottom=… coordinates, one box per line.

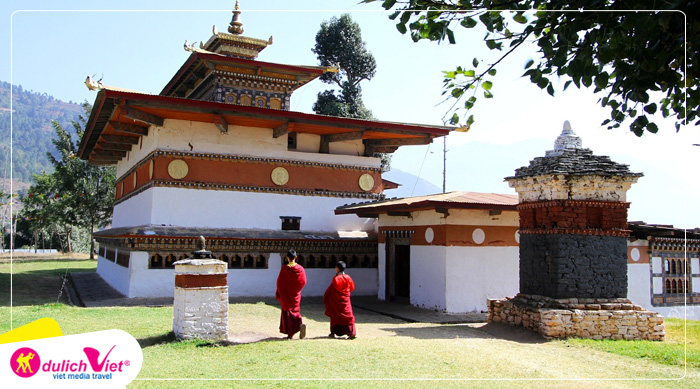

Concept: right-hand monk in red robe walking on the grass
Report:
left=323, top=261, right=356, bottom=339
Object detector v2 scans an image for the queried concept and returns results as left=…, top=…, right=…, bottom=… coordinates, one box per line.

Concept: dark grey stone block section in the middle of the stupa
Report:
left=520, top=234, right=627, bottom=299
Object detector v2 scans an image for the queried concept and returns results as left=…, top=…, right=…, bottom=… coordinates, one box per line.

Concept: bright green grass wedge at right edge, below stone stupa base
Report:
left=567, top=318, right=700, bottom=369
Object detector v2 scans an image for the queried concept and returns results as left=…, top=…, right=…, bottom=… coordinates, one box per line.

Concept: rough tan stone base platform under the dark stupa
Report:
left=487, top=294, right=666, bottom=340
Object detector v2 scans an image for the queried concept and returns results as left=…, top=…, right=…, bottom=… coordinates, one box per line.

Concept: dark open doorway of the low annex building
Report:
left=386, top=238, right=411, bottom=303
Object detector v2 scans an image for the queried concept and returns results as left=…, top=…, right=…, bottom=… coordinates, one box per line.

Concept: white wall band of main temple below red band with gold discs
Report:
left=112, top=187, right=375, bottom=231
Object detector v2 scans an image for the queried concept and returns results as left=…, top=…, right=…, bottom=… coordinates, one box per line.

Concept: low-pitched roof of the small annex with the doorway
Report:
left=335, top=191, right=518, bottom=217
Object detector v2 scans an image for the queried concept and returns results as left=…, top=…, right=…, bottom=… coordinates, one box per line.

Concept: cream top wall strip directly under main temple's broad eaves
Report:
left=117, top=119, right=381, bottom=177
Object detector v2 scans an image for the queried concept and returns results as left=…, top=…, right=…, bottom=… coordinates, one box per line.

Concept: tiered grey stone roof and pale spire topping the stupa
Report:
left=505, top=121, right=643, bottom=181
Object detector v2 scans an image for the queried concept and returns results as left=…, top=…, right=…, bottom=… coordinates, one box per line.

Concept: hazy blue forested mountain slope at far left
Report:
left=0, top=81, right=83, bottom=183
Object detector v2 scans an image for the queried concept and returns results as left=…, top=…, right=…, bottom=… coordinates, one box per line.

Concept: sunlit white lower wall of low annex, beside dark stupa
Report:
left=445, top=246, right=520, bottom=313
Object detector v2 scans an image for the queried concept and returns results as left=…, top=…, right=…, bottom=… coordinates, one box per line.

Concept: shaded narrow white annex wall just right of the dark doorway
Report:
left=410, top=246, right=447, bottom=310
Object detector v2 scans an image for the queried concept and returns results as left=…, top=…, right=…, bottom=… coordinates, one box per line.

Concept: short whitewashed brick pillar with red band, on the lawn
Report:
left=173, top=259, right=228, bottom=340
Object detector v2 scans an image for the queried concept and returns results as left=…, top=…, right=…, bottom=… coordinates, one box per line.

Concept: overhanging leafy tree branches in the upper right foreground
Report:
left=364, top=0, right=700, bottom=136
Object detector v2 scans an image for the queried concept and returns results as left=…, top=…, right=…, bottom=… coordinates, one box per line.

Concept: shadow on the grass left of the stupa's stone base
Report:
left=382, top=324, right=547, bottom=344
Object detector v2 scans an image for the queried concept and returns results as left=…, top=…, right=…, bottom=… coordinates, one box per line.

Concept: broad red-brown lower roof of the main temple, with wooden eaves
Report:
left=78, top=88, right=452, bottom=165
